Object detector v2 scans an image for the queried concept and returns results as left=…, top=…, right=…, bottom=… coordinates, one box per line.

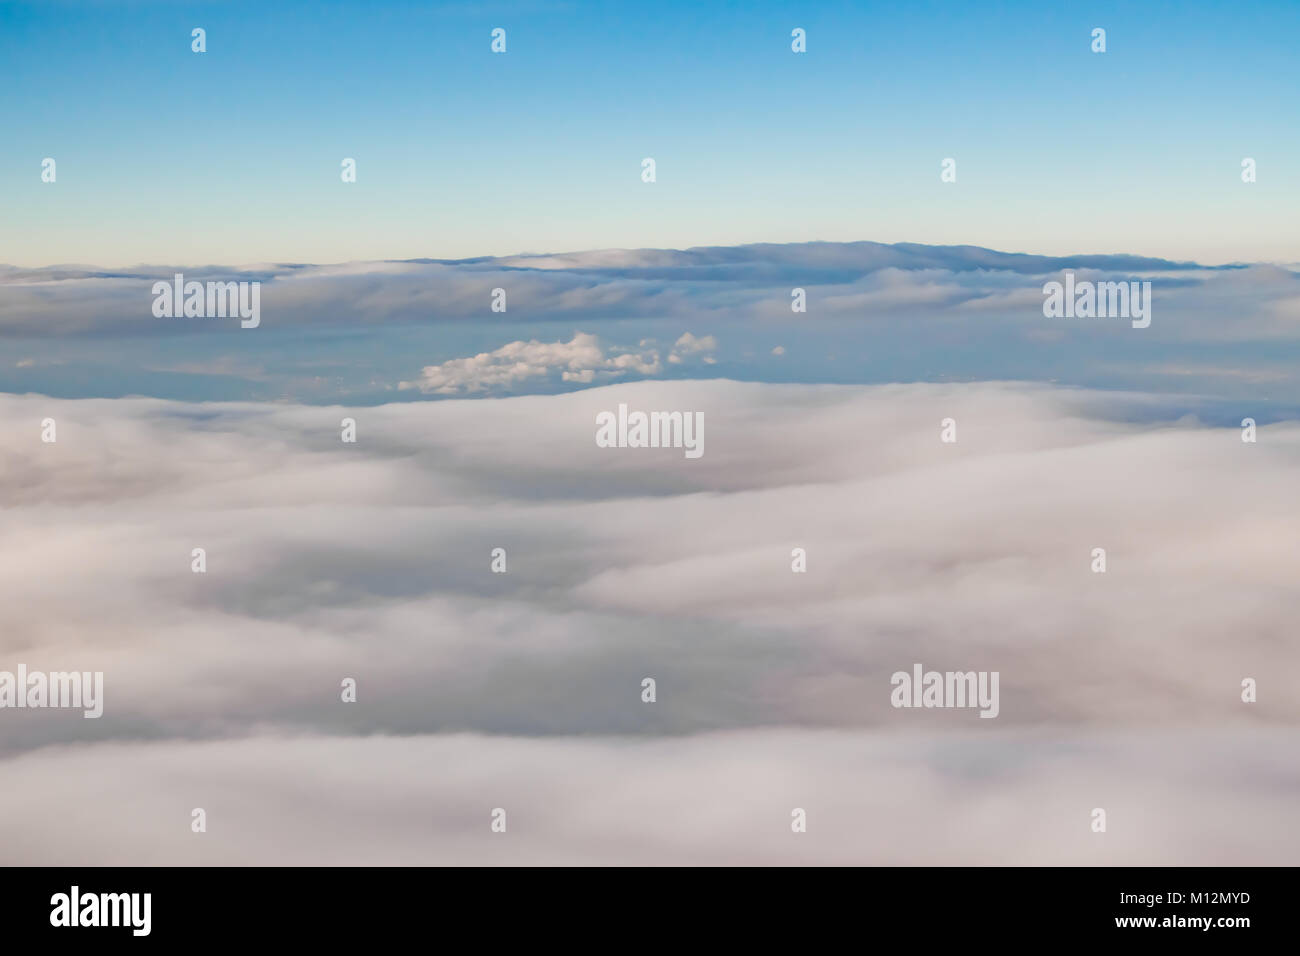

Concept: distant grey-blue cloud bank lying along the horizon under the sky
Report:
left=0, top=242, right=1274, bottom=337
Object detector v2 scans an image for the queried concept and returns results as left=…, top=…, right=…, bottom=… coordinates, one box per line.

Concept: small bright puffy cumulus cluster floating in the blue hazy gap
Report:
left=398, top=332, right=660, bottom=394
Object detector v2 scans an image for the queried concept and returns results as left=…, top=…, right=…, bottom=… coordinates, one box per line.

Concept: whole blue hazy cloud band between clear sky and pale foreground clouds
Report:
left=10, top=243, right=1300, bottom=406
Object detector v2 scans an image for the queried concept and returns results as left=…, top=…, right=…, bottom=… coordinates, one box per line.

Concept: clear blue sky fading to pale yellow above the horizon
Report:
left=0, top=0, right=1300, bottom=267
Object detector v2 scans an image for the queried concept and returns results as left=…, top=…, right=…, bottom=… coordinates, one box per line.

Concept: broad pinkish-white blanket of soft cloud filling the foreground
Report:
left=0, top=377, right=1300, bottom=864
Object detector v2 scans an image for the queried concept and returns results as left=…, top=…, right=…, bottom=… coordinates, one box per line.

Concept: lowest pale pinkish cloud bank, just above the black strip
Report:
left=0, top=728, right=1297, bottom=866
